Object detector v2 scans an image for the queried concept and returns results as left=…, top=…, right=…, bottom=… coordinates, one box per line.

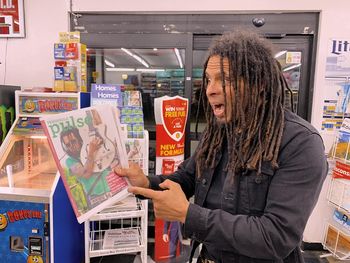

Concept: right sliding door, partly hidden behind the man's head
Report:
left=190, top=35, right=312, bottom=153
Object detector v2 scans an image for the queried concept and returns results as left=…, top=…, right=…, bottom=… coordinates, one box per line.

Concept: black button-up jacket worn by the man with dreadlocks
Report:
left=149, top=111, right=328, bottom=263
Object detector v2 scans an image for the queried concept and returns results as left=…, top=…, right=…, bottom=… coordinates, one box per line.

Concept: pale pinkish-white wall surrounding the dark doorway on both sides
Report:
left=0, top=0, right=350, bottom=252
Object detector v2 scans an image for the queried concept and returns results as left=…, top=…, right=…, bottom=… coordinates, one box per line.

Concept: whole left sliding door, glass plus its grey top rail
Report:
left=82, top=34, right=190, bottom=175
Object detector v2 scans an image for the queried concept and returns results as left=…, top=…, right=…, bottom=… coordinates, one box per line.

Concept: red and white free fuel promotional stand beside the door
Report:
left=154, top=96, right=188, bottom=262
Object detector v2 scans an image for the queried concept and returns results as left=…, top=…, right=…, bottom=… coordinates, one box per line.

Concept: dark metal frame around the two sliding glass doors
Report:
left=70, top=12, right=319, bottom=157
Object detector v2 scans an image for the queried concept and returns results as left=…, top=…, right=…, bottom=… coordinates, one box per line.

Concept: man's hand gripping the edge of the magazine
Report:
left=114, top=162, right=149, bottom=188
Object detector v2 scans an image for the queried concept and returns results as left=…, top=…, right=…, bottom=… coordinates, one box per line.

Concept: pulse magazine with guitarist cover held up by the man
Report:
left=40, top=105, right=129, bottom=223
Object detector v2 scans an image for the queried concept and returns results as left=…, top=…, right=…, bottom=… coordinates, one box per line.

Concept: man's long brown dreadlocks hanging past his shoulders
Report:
left=196, top=31, right=288, bottom=176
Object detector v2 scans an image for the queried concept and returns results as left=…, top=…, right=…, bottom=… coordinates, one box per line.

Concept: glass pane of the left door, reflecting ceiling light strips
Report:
left=88, top=46, right=185, bottom=134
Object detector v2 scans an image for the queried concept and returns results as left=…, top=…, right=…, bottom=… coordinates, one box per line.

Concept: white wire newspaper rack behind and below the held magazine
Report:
left=84, top=130, right=149, bottom=263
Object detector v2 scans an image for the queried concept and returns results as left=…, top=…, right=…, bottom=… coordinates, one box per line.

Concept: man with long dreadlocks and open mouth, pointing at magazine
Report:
left=115, top=31, right=328, bottom=263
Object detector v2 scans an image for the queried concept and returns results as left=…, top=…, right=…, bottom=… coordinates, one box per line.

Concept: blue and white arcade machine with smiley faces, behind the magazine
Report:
left=0, top=91, right=90, bottom=263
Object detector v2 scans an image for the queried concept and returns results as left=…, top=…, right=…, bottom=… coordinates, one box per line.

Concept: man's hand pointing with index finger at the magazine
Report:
left=129, top=180, right=189, bottom=223
